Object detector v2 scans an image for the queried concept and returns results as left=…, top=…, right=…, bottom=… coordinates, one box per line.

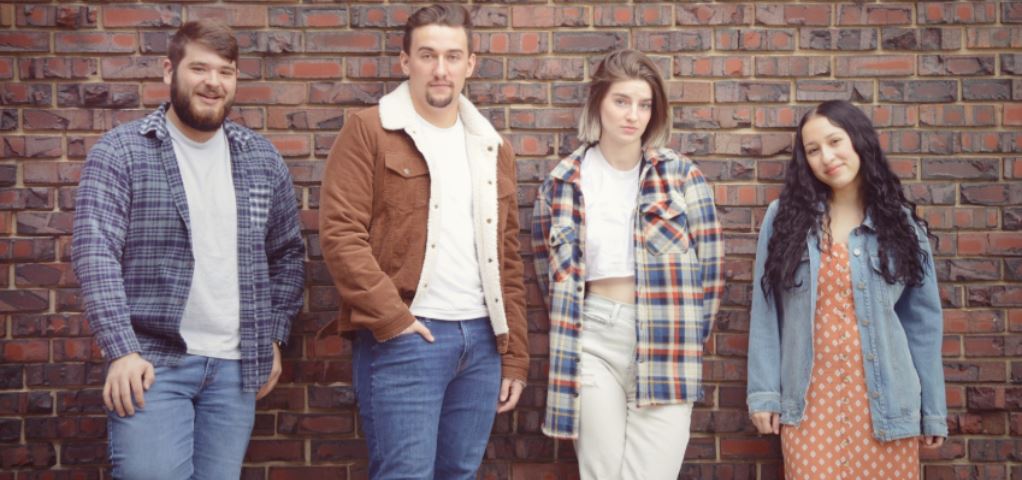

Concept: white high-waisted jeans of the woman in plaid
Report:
left=575, top=294, right=692, bottom=480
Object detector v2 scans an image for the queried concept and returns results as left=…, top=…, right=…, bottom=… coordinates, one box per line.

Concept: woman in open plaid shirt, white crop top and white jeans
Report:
left=532, top=50, right=724, bottom=480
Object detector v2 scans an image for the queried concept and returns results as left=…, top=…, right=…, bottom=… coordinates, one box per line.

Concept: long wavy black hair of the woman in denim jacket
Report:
left=760, top=100, right=929, bottom=304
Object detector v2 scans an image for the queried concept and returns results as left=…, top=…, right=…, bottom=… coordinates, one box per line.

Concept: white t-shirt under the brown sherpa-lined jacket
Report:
left=411, top=115, right=489, bottom=321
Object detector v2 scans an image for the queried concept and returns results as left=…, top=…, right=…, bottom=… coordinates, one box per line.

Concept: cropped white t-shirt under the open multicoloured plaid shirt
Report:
left=582, top=146, right=642, bottom=281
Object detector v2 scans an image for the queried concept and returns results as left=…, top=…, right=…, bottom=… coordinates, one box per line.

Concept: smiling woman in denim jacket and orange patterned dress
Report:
left=747, top=101, right=947, bottom=479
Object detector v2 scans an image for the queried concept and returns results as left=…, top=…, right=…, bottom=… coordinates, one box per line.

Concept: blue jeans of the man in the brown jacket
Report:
left=354, top=318, right=501, bottom=480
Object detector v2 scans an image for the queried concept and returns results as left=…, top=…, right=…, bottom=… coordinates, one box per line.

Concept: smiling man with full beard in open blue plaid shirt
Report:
left=73, top=20, right=305, bottom=479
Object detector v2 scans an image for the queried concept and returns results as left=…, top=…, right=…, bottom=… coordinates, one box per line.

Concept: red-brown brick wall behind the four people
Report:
left=0, top=0, right=1022, bottom=480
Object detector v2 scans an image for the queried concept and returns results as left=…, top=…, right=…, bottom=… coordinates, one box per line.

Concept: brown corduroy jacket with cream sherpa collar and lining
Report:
left=319, top=84, right=528, bottom=381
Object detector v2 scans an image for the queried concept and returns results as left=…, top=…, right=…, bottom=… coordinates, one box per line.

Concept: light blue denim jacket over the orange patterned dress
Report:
left=747, top=200, right=947, bottom=441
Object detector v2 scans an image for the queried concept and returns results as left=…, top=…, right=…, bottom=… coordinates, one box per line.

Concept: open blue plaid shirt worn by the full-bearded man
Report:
left=72, top=104, right=305, bottom=391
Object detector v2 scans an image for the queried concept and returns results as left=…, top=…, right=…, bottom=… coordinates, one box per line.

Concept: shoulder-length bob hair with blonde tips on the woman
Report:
left=578, top=49, right=670, bottom=148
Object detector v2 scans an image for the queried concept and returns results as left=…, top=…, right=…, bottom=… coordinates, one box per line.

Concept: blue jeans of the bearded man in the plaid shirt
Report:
left=107, top=355, right=256, bottom=480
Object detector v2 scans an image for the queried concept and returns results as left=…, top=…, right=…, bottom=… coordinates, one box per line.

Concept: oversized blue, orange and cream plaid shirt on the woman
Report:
left=532, top=142, right=724, bottom=438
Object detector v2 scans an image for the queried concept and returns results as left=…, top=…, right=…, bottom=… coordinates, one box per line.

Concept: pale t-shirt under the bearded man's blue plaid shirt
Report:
left=167, top=119, right=241, bottom=359
